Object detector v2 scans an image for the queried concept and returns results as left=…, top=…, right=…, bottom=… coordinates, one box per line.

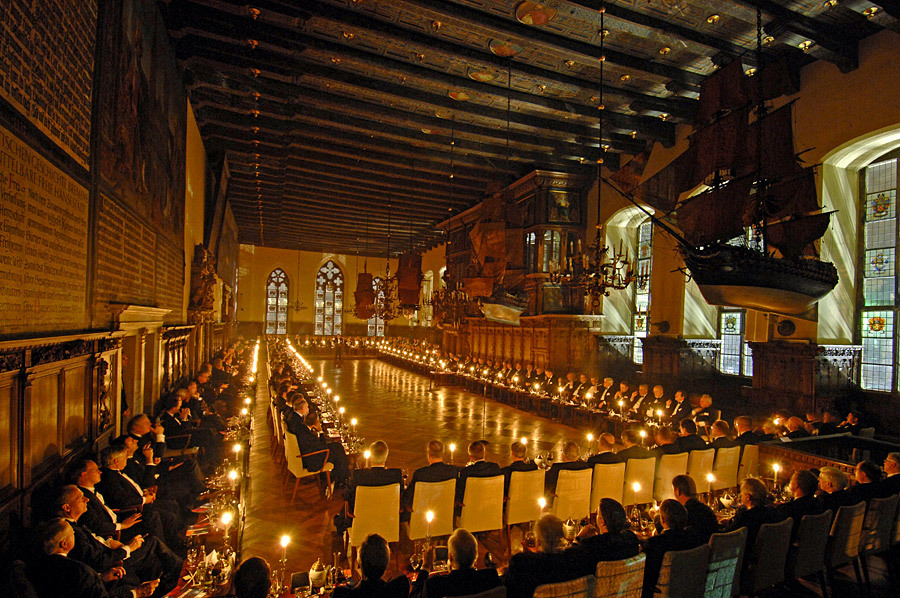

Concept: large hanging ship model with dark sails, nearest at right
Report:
left=614, top=60, right=838, bottom=315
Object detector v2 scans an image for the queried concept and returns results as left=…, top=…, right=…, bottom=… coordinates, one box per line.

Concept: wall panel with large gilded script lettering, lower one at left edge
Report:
left=0, top=127, right=88, bottom=335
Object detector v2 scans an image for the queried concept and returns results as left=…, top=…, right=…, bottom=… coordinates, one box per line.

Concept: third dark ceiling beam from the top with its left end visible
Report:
left=185, top=68, right=652, bottom=159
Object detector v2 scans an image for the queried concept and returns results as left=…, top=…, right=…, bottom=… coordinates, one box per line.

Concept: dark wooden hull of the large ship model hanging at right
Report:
left=684, top=245, right=838, bottom=315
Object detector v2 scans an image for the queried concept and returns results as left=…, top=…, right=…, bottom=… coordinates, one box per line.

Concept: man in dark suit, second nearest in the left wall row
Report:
left=54, top=485, right=182, bottom=598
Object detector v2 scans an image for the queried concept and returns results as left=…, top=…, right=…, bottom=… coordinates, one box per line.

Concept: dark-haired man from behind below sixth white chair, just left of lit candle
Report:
left=564, top=498, right=641, bottom=576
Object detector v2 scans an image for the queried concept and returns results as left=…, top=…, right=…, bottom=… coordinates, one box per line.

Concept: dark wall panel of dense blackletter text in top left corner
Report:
left=0, top=0, right=97, bottom=168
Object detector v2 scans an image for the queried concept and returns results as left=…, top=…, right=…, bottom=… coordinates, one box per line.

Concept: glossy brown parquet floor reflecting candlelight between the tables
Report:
left=243, top=354, right=897, bottom=596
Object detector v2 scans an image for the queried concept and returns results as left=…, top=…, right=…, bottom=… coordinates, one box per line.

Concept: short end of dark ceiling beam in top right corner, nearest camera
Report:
left=733, top=0, right=859, bottom=72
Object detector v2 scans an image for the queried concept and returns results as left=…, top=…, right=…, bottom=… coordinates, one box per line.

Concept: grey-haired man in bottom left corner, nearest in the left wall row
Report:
left=27, top=517, right=146, bottom=598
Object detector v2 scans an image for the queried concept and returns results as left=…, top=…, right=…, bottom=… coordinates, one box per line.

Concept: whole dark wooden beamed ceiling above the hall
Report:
left=162, top=0, right=900, bottom=256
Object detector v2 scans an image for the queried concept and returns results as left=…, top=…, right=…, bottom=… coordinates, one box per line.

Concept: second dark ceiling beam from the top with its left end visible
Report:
left=178, top=46, right=675, bottom=143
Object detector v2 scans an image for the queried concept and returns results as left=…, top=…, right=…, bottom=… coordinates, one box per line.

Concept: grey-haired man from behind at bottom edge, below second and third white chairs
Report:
left=425, top=528, right=500, bottom=598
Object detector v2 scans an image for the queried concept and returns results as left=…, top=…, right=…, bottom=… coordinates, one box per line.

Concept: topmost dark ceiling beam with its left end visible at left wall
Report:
left=177, top=5, right=693, bottom=129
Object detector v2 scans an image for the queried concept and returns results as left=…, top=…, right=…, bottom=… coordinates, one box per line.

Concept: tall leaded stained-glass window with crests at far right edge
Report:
left=857, top=152, right=900, bottom=391
